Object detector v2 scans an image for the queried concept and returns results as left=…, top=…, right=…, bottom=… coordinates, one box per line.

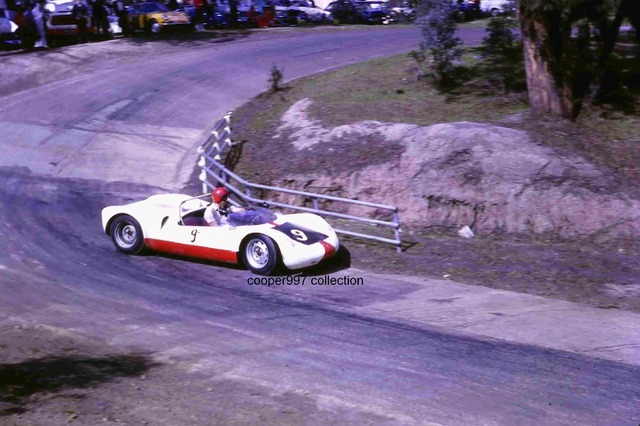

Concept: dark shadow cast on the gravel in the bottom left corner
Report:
left=0, top=354, right=157, bottom=417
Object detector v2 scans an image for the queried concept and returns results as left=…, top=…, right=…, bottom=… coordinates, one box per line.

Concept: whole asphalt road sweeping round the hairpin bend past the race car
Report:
left=0, top=30, right=640, bottom=425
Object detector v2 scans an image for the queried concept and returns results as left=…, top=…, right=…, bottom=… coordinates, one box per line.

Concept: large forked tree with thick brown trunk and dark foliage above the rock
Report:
left=519, top=0, right=640, bottom=119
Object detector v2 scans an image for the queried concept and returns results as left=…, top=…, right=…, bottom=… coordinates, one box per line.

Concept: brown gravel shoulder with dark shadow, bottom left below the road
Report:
left=0, top=322, right=384, bottom=426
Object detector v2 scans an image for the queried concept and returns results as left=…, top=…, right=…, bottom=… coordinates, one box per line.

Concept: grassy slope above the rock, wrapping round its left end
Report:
left=231, top=53, right=528, bottom=184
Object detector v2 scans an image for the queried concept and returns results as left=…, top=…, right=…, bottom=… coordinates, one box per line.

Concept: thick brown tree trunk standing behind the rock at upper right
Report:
left=520, top=8, right=575, bottom=119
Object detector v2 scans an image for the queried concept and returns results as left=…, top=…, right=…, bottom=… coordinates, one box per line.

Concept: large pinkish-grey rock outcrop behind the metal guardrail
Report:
left=276, top=100, right=640, bottom=237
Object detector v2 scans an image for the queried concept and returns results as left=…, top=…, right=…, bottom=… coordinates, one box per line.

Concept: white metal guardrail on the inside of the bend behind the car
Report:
left=198, top=112, right=402, bottom=252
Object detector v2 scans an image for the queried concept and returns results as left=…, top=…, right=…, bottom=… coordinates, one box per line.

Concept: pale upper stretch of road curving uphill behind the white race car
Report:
left=0, top=28, right=438, bottom=189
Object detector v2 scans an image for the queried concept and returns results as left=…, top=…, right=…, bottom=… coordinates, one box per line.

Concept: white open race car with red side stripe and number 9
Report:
left=102, top=194, right=339, bottom=275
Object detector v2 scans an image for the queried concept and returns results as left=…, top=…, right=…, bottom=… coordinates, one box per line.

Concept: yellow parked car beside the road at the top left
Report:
left=127, top=2, right=191, bottom=34
